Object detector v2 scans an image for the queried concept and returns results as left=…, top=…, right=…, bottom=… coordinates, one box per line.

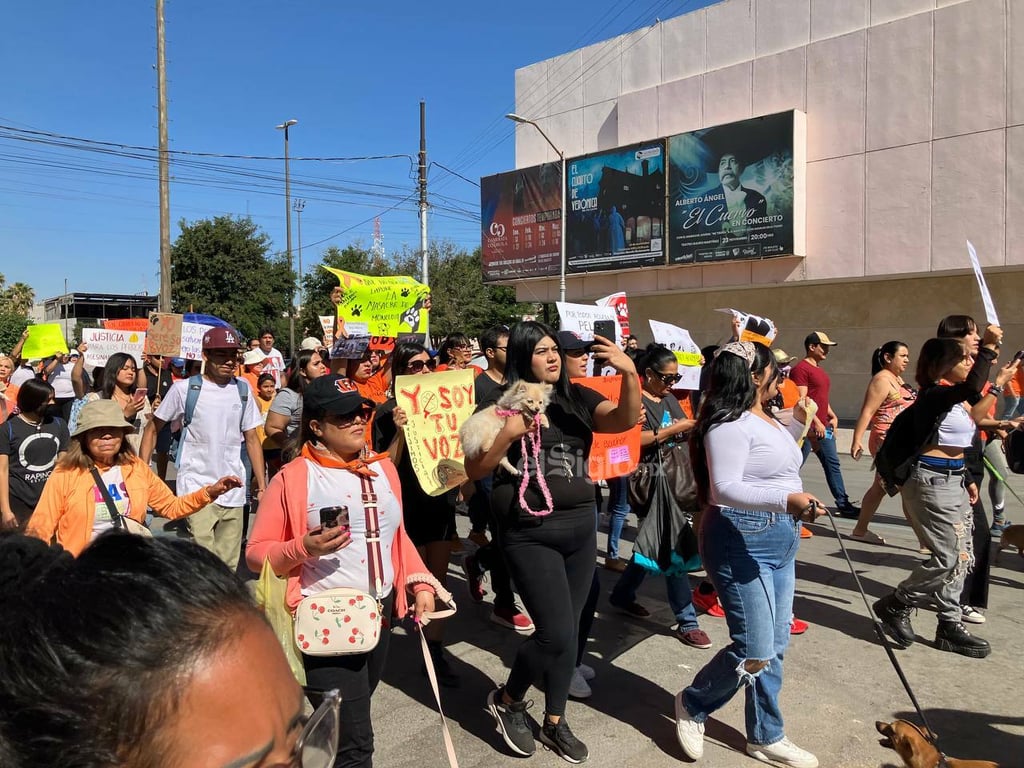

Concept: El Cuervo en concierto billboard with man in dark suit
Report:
left=668, top=111, right=805, bottom=264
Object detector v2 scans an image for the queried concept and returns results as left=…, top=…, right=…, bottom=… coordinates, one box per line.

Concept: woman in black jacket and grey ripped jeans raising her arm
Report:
left=874, top=326, right=1017, bottom=658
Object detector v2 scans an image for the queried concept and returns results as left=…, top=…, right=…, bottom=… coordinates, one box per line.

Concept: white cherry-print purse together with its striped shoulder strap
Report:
left=295, top=477, right=384, bottom=656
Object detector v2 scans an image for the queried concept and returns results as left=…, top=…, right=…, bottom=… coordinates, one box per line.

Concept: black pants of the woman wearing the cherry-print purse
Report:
left=302, top=592, right=393, bottom=768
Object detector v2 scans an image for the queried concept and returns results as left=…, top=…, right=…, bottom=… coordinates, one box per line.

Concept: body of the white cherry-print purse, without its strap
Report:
left=295, top=588, right=382, bottom=656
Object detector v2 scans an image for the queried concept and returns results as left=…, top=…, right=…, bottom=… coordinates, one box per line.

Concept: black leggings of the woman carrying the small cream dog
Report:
left=500, top=512, right=597, bottom=717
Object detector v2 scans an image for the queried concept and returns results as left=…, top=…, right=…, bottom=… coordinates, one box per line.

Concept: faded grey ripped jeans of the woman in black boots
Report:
left=896, top=464, right=974, bottom=622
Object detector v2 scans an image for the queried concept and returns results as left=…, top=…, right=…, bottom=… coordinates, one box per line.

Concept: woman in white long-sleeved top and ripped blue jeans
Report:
left=676, top=342, right=823, bottom=768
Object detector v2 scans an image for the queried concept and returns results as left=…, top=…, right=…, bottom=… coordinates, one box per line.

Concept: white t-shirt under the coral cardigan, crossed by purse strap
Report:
left=300, top=459, right=401, bottom=597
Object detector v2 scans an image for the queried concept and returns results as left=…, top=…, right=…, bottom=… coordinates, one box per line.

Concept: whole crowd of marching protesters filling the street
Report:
left=0, top=288, right=1021, bottom=768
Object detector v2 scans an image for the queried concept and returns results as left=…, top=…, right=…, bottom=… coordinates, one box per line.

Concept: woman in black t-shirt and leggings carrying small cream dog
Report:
left=466, top=323, right=640, bottom=763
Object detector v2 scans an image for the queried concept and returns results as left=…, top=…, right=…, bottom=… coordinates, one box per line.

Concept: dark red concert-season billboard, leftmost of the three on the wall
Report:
left=480, top=163, right=562, bottom=282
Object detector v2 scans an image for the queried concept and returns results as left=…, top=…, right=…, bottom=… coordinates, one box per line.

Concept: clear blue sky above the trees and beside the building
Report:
left=0, top=0, right=712, bottom=300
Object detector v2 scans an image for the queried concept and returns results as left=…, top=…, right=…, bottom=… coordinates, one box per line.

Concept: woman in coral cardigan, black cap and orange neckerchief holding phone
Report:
left=246, top=374, right=437, bottom=768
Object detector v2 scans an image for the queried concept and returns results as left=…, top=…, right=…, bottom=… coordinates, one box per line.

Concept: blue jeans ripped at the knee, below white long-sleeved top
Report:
left=683, top=507, right=800, bottom=744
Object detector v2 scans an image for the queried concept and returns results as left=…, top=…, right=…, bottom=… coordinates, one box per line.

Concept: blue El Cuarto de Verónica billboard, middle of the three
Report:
left=565, top=139, right=665, bottom=272
